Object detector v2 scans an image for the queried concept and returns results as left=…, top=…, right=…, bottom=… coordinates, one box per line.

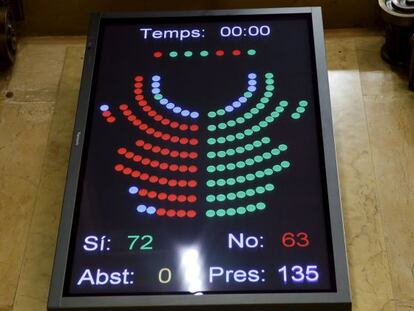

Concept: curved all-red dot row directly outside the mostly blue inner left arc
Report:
left=135, top=76, right=199, bottom=132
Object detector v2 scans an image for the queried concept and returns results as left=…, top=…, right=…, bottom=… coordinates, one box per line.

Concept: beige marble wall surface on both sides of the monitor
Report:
left=0, top=30, right=414, bottom=311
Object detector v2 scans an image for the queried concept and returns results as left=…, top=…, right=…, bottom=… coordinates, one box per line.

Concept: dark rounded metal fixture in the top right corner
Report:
left=378, top=0, right=414, bottom=91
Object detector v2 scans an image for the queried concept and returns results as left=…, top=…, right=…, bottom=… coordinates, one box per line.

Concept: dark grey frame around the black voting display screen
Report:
left=48, top=7, right=352, bottom=311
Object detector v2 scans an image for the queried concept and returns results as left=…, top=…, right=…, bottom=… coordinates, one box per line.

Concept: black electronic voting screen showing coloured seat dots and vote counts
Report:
left=64, top=14, right=336, bottom=296
